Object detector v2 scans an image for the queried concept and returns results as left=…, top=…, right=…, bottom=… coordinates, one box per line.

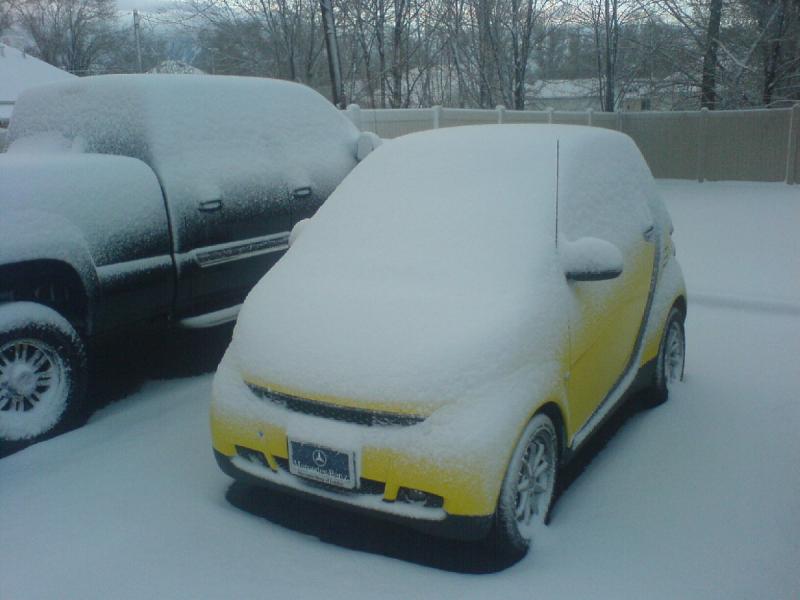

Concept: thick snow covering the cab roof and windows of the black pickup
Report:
left=8, top=75, right=359, bottom=250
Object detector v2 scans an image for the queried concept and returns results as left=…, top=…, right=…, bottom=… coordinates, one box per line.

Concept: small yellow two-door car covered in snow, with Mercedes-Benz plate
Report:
left=211, top=125, right=686, bottom=555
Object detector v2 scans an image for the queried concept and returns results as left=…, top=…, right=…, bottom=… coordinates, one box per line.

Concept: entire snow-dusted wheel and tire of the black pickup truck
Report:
left=0, top=302, right=86, bottom=444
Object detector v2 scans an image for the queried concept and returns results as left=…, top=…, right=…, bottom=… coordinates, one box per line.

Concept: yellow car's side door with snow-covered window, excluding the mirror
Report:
left=559, top=145, right=655, bottom=430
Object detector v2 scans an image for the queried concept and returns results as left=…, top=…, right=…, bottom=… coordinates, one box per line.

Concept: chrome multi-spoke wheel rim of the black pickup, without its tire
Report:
left=0, top=339, right=66, bottom=414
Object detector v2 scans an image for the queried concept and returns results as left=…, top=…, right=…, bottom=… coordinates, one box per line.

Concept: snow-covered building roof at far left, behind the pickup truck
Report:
left=0, top=43, right=75, bottom=127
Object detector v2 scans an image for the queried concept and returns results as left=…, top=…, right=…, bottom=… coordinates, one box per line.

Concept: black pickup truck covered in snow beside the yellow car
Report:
left=0, top=75, right=379, bottom=444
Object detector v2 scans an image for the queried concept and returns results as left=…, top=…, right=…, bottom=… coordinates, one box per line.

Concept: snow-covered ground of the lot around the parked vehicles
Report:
left=0, top=182, right=800, bottom=600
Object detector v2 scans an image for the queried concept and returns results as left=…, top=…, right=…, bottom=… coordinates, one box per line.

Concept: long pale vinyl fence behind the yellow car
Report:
left=346, top=104, right=800, bottom=183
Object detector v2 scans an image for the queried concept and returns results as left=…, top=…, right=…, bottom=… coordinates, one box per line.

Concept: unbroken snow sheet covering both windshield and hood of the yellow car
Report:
left=231, top=126, right=566, bottom=410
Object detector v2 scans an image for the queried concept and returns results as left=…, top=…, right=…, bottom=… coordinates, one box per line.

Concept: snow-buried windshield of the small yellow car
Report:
left=290, top=127, right=556, bottom=286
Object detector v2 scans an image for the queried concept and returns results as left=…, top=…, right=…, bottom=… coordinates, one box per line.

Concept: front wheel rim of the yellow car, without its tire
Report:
left=514, top=428, right=556, bottom=535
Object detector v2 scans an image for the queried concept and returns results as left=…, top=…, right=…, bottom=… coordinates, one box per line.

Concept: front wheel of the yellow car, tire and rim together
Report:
left=489, top=413, right=559, bottom=559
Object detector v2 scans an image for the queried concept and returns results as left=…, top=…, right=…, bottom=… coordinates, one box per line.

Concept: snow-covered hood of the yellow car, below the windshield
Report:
left=232, top=255, right=564, bottom=415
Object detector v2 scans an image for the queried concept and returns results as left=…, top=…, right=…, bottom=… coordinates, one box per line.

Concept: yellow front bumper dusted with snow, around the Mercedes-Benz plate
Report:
left=206, top=352, right=506, bottom=539
